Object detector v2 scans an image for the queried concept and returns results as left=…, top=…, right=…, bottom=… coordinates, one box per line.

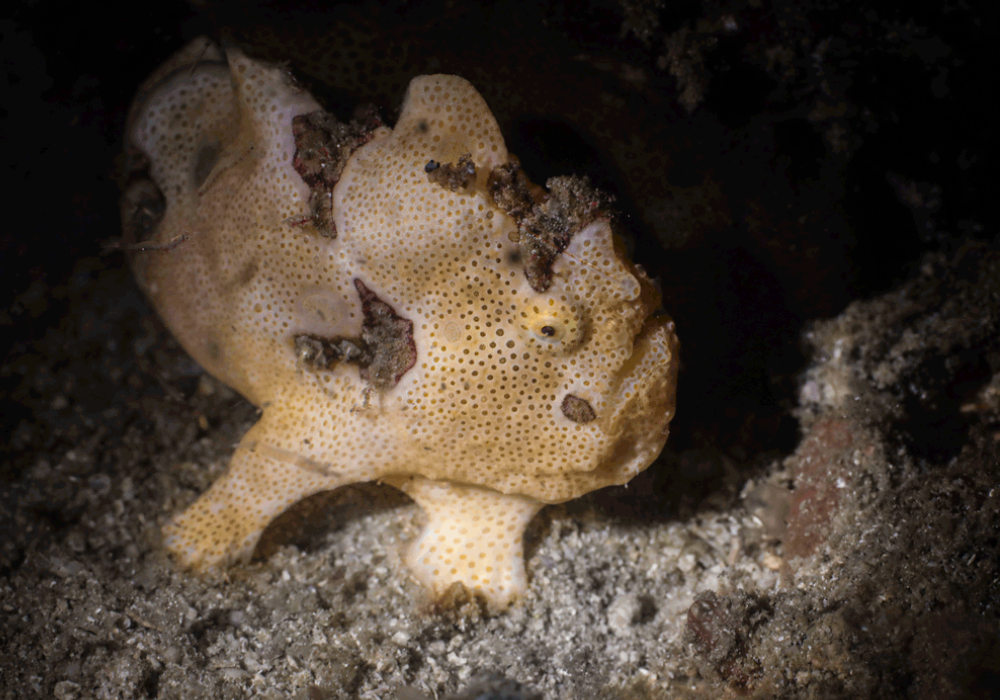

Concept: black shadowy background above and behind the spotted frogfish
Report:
left=0, top=0, right=998, bottom=508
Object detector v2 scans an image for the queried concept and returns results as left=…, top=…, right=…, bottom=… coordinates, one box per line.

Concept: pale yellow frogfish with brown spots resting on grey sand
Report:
left=123, top=40, right=677, bottom=608
